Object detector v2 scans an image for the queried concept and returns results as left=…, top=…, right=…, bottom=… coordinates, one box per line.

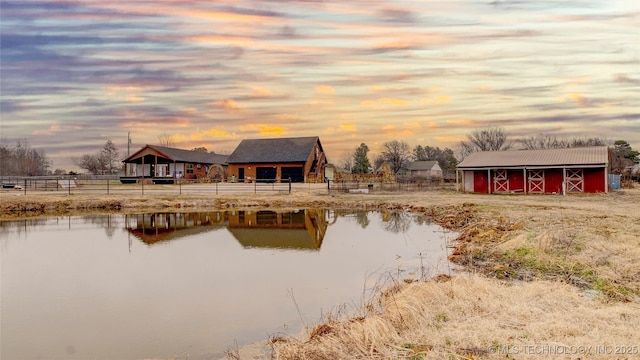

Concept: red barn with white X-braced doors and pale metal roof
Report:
left=456, top=146, right=609, bottom=194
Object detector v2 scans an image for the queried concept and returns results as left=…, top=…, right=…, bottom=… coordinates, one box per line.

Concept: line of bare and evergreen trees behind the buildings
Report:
left=0, top=127, right=640, bottom=176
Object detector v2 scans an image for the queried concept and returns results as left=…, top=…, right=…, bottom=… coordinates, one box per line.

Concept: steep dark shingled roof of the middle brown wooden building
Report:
left=227, top=136, right=322, bottom=164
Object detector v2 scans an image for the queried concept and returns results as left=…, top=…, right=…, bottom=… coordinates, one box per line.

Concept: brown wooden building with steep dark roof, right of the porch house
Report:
left=227, top=136, right=327, bottom=182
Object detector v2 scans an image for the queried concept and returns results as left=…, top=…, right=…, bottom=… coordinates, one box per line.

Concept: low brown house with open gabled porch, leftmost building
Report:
left=120, top=145, right=229, bottom=183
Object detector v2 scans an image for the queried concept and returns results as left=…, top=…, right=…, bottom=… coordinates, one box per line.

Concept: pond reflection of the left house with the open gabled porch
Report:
left=125, top=211, right=226, bottom=245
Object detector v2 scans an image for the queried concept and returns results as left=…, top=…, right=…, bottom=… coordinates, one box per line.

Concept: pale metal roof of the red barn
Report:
left=458, top=146, right=609, bottom=169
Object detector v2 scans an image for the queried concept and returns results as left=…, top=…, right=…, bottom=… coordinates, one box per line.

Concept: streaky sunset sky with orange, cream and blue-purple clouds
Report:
left=0, top=0, right=640, bottom=170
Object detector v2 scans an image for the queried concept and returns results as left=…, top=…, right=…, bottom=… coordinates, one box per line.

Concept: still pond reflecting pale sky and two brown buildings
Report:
left=0, top=209, right=454, bottom=359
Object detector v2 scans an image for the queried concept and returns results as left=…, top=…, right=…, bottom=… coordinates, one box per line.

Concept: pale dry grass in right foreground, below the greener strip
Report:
left=272, top=275, right=640, bottom=359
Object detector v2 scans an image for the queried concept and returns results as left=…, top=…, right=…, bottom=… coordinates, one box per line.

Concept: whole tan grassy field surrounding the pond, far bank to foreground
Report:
left=0, top=188, right=640, bottom=359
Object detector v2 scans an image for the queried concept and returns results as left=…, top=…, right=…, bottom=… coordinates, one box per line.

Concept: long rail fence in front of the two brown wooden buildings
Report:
left=0, top=176, right=292, bottom=195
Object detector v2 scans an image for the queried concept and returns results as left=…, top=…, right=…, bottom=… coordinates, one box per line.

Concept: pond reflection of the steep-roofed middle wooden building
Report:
left=228, top=209, right=327, bottom=250
